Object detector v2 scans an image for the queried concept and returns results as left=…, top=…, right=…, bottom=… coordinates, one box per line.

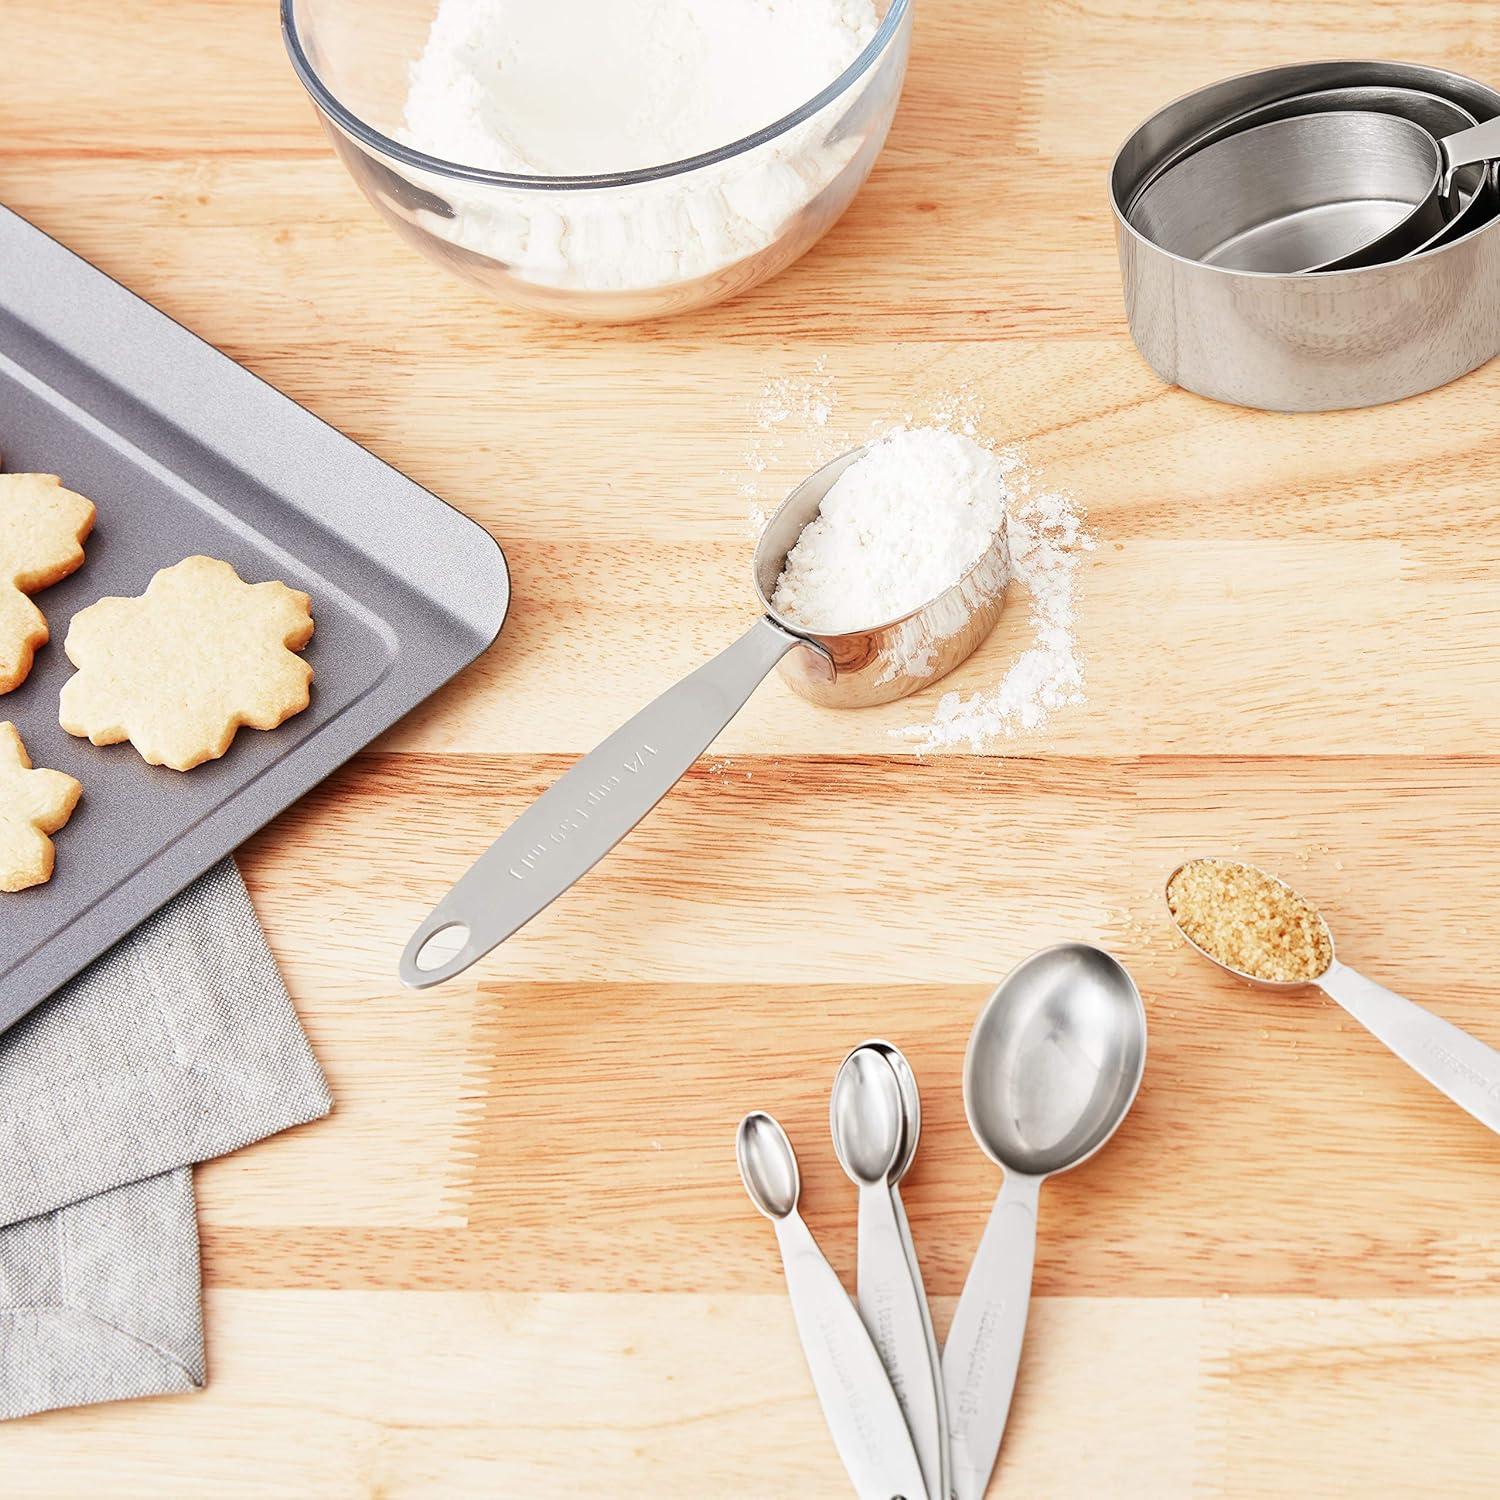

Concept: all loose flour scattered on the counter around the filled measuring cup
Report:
left=738, top=359, right=1095, bottom=755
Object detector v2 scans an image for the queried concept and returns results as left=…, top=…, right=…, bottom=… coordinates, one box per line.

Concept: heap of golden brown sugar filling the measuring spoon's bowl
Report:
left=1167, top=860, right=1334, bottom=984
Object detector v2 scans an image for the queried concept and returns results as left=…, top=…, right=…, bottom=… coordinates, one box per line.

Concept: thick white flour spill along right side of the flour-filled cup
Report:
left=897, top=467, right=1095, bottom=752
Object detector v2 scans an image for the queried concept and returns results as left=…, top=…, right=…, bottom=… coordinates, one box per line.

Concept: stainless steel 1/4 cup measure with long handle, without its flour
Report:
left=401, top=449, right=1010, bottom=989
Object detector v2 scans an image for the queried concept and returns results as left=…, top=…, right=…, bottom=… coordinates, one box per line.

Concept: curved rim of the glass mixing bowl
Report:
left=281, top=0, right=912, bottom=192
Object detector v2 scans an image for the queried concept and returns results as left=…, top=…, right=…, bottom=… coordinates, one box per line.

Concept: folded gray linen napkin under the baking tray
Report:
left=0, top=860, right=333, bottom=1419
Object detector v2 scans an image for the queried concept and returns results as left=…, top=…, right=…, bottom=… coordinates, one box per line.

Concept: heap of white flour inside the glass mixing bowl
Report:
left=401, top=0, right=879, bottom=290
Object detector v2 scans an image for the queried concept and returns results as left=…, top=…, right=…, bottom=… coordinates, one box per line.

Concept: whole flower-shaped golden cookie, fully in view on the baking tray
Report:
left=59, top=558, right=312, bottom=771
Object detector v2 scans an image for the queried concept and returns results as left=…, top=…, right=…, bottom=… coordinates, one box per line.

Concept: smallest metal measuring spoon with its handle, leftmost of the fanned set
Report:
left=735, top=1110, right=927, bottom=1500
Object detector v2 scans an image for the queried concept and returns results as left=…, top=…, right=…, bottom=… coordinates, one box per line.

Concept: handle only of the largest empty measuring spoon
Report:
left=942, top=1172, right=1041, bottom=1500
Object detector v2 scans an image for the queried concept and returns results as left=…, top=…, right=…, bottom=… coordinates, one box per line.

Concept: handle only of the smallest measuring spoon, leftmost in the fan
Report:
left=776, top=1214, right=927, bottom=1500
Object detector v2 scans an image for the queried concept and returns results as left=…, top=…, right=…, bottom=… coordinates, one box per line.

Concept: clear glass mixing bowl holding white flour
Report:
left=282, top=0, right=912, bottom=323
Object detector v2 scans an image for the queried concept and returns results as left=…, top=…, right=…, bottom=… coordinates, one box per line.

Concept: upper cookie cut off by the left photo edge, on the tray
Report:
left=0, top=474, right=95, bottom=693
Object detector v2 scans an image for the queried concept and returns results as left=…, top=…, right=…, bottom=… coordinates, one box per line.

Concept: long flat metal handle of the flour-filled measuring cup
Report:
left=401, top=618, right=804, bottom=990
